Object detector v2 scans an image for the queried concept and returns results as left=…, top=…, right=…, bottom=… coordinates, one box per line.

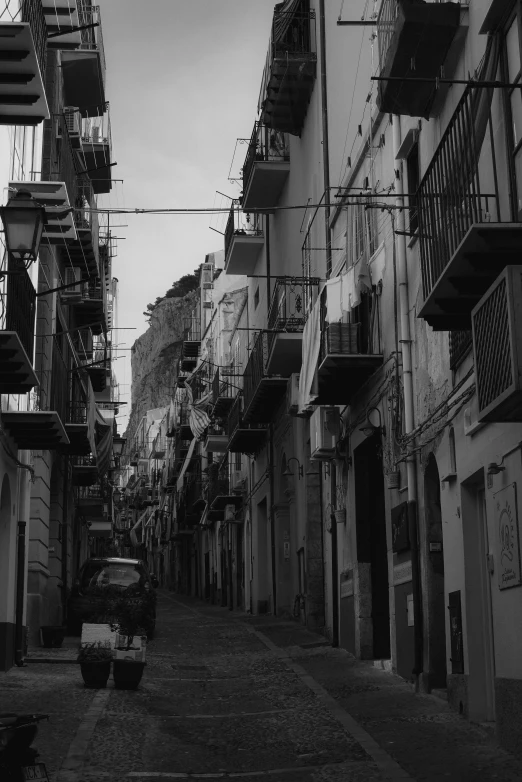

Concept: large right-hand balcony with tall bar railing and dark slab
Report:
left=417, top=87, right=522, bottom=331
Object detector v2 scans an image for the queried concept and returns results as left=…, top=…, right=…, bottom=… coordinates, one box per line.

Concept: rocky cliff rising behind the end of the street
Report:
left=125, top=291, right=199, bottom=437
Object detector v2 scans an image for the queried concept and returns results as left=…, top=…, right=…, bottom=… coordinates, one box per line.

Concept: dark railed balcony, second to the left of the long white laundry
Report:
left=243, top=331, right=288, bottom=424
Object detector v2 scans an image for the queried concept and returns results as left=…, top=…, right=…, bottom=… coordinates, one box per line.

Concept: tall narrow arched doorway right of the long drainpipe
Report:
left=424, top=454, right=447, bottom=689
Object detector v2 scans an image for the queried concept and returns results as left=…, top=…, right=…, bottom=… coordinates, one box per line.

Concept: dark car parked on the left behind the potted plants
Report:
left=67, top=557, right=159, bottom=639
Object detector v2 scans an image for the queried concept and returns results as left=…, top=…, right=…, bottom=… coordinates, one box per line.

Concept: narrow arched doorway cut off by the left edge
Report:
left=0, top=475, right=16, bottom=670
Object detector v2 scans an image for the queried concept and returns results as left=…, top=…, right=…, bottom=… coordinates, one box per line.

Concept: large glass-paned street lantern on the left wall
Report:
left=0, top=190, right=46, bottom=264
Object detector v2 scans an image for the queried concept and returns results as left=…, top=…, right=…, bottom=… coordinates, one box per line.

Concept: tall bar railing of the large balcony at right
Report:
left=417, top=85, right=506, bottom=299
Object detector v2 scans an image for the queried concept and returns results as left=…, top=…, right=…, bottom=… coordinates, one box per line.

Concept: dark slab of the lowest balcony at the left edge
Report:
left=2, top=410, right=69, bottom=451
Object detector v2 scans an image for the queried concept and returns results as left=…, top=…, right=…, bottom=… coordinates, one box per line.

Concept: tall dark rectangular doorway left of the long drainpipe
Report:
left=354, top=435, right=390, bottom=659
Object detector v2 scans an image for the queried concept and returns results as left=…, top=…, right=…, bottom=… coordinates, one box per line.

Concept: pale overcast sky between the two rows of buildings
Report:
left=99, top=0, right=274, bottom=431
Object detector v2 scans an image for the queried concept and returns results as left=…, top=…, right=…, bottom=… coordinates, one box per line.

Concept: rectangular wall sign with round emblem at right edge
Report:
left=493, top=483, right=522, bottom=589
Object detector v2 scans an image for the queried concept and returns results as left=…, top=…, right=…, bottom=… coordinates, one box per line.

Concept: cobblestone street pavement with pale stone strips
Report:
left=0, top=592, right=522, bottom=782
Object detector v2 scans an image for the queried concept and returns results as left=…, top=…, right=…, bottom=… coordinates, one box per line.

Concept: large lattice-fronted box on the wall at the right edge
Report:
left=471, top=266, right=522, bottom=422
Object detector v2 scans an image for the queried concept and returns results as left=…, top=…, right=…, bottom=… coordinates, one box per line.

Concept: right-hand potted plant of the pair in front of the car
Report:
left=110, top=597, right=146, bottom=690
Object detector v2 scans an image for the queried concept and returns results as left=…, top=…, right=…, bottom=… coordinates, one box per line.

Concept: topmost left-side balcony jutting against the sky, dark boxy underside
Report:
left=60, top=4, right=105, bottom=117
